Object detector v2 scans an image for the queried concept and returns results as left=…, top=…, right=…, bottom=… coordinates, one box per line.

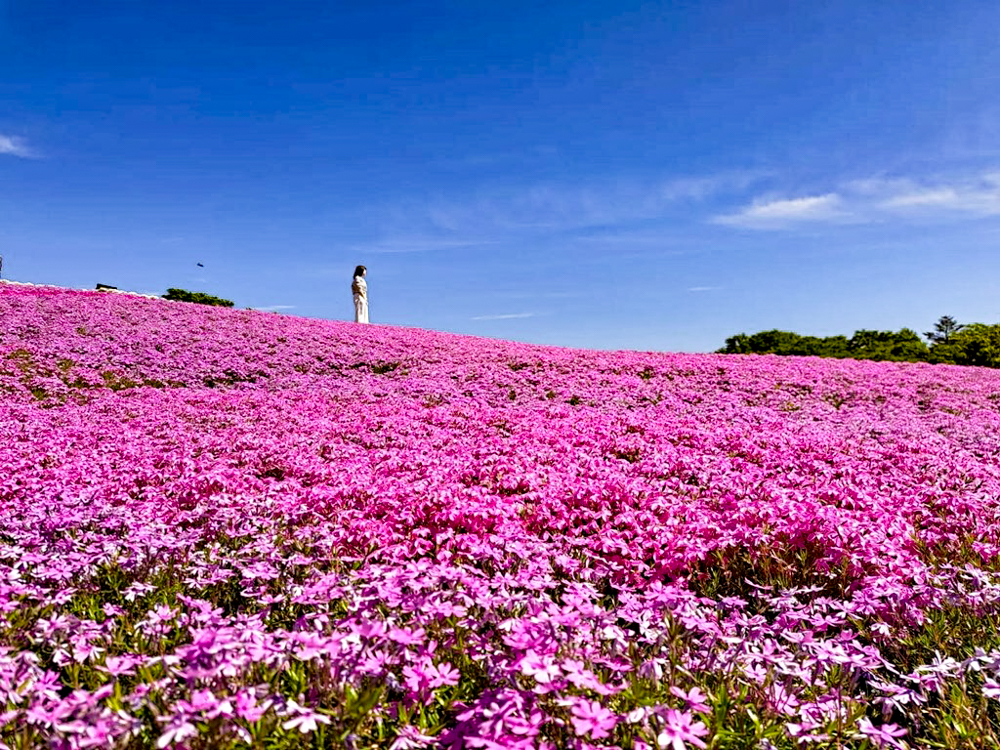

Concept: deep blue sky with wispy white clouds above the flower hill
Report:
left=0, top=0, right=1000, bottom=351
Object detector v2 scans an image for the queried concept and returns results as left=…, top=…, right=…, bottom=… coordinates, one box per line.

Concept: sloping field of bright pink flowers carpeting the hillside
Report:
left=0, top=284, right=1000, bottom=750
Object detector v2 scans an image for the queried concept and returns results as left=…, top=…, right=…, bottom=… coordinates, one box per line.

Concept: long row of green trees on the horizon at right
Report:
left=718, top=315, right=1000, bottom=367
